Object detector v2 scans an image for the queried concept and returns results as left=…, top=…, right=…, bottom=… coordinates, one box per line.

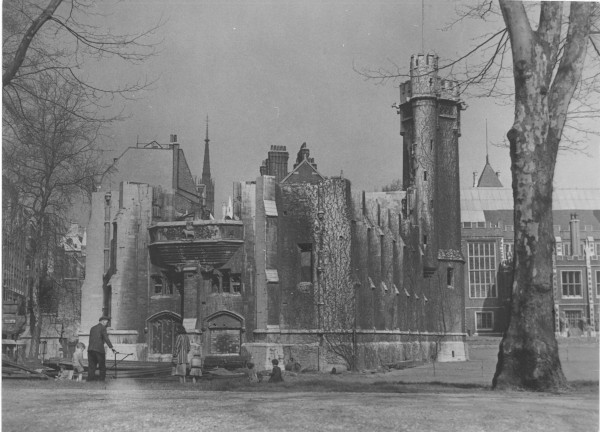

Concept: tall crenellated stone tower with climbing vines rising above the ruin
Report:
left=399, top=54, right=461, bottom=277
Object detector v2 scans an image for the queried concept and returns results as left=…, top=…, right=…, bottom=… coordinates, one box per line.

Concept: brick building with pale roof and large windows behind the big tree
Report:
left=461, top=160, right=600, bottom=336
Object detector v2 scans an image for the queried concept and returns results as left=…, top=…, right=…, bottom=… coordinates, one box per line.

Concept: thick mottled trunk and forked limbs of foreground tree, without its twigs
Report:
left=493, top=0, right=593, bottom=390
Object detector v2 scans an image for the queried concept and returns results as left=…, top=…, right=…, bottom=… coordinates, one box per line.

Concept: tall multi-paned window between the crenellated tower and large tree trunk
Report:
left=467, top=241, right=498, bottom=299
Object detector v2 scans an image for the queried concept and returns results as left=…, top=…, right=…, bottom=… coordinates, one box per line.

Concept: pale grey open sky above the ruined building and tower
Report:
left=86, top=0, right=600, bottom=216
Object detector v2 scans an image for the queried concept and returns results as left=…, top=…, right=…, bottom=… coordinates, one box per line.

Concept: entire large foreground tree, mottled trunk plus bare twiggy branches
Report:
left=360, top=0, right=600, bottom=390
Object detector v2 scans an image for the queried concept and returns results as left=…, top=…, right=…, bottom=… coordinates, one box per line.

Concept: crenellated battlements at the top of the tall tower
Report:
left=400, top=54, right=460, bottom=104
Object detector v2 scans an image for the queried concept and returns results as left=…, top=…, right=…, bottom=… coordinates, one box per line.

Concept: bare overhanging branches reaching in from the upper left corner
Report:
left=2, top=0, right=160, bottom=120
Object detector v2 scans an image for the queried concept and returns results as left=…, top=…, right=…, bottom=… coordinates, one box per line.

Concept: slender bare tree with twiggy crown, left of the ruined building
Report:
left=2, top=74, right=104, bottom=357
